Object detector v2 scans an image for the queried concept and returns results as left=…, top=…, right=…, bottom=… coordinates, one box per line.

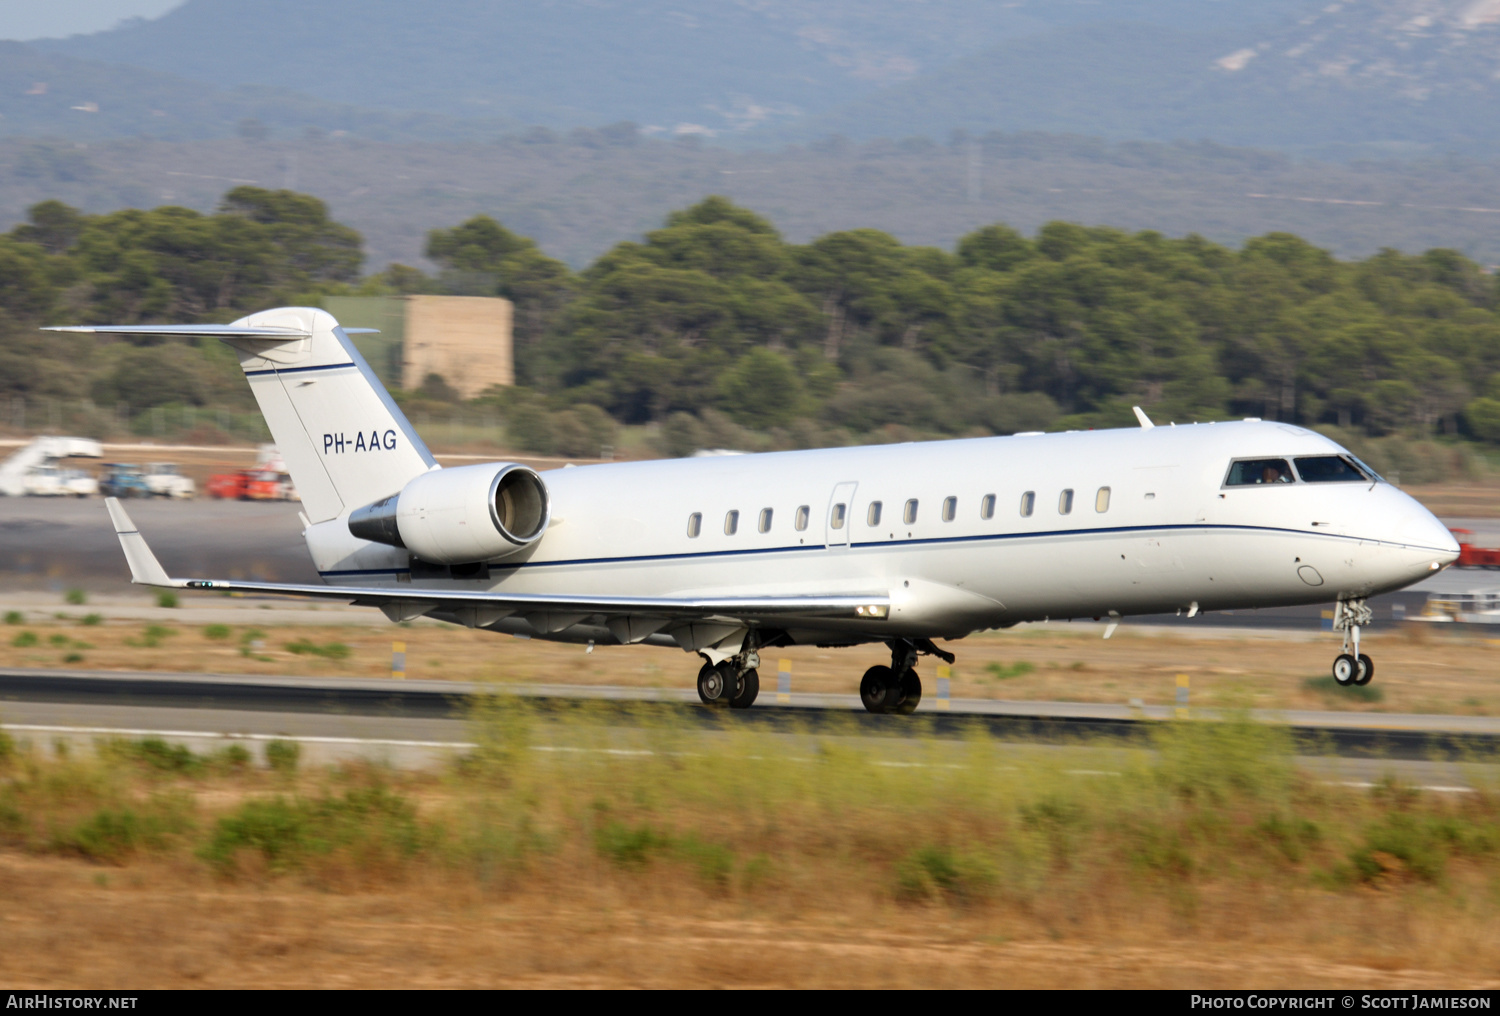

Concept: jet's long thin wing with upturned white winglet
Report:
left=105, top=497, right=890, bottom=620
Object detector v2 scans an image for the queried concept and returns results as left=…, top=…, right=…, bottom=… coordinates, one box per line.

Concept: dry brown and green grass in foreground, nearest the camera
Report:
left=0, top=701, right=1500, bottom=987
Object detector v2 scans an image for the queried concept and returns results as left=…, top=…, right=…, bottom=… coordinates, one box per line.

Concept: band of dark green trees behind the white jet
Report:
left=0, top=188, right=1500, bottom=480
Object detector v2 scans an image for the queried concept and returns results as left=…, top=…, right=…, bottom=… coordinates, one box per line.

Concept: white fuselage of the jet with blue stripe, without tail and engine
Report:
left=306, top=422, right=1458, bottom=642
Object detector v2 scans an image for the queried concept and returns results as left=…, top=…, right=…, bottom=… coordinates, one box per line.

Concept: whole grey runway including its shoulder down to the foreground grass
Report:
left=0, top=669, right=1500, bottom=792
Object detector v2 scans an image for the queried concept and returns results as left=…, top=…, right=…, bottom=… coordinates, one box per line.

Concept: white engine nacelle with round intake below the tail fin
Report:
left=350, top=462, right=552, bottom=564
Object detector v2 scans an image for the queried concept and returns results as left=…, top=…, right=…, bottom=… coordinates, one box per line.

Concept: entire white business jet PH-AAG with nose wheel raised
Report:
left=46, top=308, right=1458, bottom=713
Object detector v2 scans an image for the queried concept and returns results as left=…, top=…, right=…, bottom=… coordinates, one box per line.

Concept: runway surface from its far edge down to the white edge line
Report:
left=0, top=669, right=1500, bottom=759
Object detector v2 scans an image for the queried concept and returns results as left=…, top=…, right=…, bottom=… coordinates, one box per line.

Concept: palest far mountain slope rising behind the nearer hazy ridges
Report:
left=26, top=0, right=1304, bottom=132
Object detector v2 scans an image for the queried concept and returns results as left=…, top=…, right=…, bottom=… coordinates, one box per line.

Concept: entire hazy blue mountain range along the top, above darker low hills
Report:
left=0, top=0, right=1500, bottom=156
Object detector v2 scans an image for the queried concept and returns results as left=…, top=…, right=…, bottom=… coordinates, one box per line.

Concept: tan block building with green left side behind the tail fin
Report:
left=323, top=296, right=516, bottom=399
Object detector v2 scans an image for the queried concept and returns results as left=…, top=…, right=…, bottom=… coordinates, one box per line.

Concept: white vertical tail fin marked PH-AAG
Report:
left=222, top=308, right=437, bottom=522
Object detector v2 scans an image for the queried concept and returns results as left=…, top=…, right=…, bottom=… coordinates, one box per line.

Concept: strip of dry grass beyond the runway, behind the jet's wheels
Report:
left=0, top=606, right=1500, bottom=716
